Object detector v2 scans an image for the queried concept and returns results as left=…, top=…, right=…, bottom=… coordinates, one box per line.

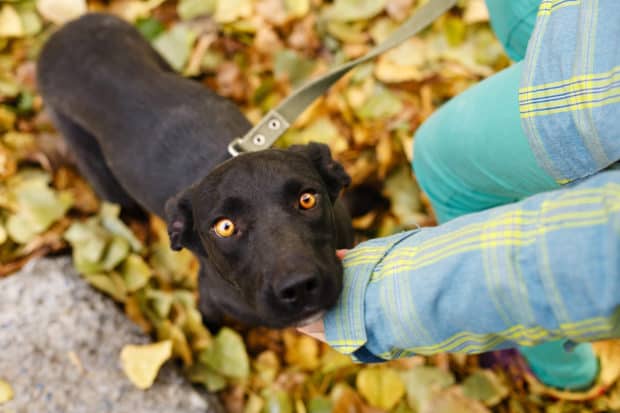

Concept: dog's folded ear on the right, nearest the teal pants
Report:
left=289, top=142, right=351, bottom=202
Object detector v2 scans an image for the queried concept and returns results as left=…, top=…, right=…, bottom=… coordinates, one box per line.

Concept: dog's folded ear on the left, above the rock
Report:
left=164, top=188, right=200, bottom=251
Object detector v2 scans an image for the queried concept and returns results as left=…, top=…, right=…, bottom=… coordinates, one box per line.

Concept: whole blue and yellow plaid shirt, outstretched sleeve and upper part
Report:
left=325, top=0, right=620, bottom=362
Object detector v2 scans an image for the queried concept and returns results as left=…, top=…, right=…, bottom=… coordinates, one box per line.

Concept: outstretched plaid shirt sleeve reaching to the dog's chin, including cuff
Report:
left=325, top=170, right=620, bottom=362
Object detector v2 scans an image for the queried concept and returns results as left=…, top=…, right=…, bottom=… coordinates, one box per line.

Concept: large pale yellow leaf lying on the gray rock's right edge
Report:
left=121, top=340, right=172, bottom=390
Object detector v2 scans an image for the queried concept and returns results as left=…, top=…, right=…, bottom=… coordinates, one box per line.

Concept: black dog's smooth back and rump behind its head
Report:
left=37, top=14, right=250, bottom=215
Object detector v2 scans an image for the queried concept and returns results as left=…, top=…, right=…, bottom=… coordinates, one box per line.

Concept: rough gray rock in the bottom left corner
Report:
left=0, top=258, right=221, bottom=413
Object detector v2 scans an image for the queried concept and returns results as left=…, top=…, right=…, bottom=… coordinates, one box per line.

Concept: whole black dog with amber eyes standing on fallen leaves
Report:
left=37, top=14, right=352, bottom=327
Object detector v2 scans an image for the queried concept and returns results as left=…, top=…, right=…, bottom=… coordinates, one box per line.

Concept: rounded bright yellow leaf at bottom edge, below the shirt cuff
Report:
left=355, top=367, right=405, bottom=410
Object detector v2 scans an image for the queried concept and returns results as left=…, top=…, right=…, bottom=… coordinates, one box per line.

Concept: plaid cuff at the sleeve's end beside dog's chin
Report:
left=323, top=230, right=419, bottom=363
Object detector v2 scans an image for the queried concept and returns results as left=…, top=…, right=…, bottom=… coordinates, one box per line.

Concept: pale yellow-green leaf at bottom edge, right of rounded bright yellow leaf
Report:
left=401, top=366, right=454, bottom=411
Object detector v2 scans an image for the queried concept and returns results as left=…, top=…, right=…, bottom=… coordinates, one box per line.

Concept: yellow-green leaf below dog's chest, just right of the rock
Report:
left=200, top=327, right=250, bottom=379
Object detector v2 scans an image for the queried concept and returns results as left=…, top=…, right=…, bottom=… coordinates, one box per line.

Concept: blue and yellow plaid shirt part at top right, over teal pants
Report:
left=519, top=0, right=620, bottom=184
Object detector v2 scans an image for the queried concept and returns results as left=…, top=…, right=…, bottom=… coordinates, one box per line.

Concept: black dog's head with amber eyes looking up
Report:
left=166, top=143, right=350, bottom=327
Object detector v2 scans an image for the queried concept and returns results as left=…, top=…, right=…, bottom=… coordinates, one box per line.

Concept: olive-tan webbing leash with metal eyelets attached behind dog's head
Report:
left=228, top=0, right=457, bottom=157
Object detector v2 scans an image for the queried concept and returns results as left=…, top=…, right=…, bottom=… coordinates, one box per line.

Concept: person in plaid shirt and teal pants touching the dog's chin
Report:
left=301, top=0, right=620, bottom=390
